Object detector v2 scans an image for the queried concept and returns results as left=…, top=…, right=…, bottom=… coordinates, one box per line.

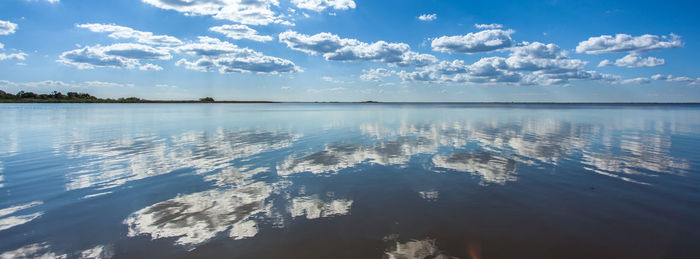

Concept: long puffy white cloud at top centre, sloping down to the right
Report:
left=279, top=30, right=437, bottom=67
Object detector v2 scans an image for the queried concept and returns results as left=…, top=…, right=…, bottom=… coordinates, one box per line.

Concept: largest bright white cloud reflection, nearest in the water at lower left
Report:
left=124, top=182, right=273, bottom=246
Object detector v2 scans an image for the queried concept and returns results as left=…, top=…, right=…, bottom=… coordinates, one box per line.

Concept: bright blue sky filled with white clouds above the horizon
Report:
left=0, top=0, right=700, bottom=102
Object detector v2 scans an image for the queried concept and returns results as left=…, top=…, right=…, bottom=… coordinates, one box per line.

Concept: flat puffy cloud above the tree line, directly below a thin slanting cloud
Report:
left=58, top=43, right=172, bottom=69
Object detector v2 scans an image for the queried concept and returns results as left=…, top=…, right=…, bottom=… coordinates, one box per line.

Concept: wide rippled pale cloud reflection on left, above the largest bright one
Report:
left=57, top=130, right=300, bottom=193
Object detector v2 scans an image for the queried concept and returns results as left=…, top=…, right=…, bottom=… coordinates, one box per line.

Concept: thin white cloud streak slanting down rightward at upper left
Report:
left=77, top=23, right=182, bottom=45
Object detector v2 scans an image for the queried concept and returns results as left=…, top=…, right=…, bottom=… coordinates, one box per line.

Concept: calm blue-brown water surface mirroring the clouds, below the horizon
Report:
left=0, top=104, right=700, bottom=258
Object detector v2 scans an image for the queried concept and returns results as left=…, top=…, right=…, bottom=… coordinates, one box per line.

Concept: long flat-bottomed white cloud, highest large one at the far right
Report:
left=576, top=33, right=683, bottom=54
